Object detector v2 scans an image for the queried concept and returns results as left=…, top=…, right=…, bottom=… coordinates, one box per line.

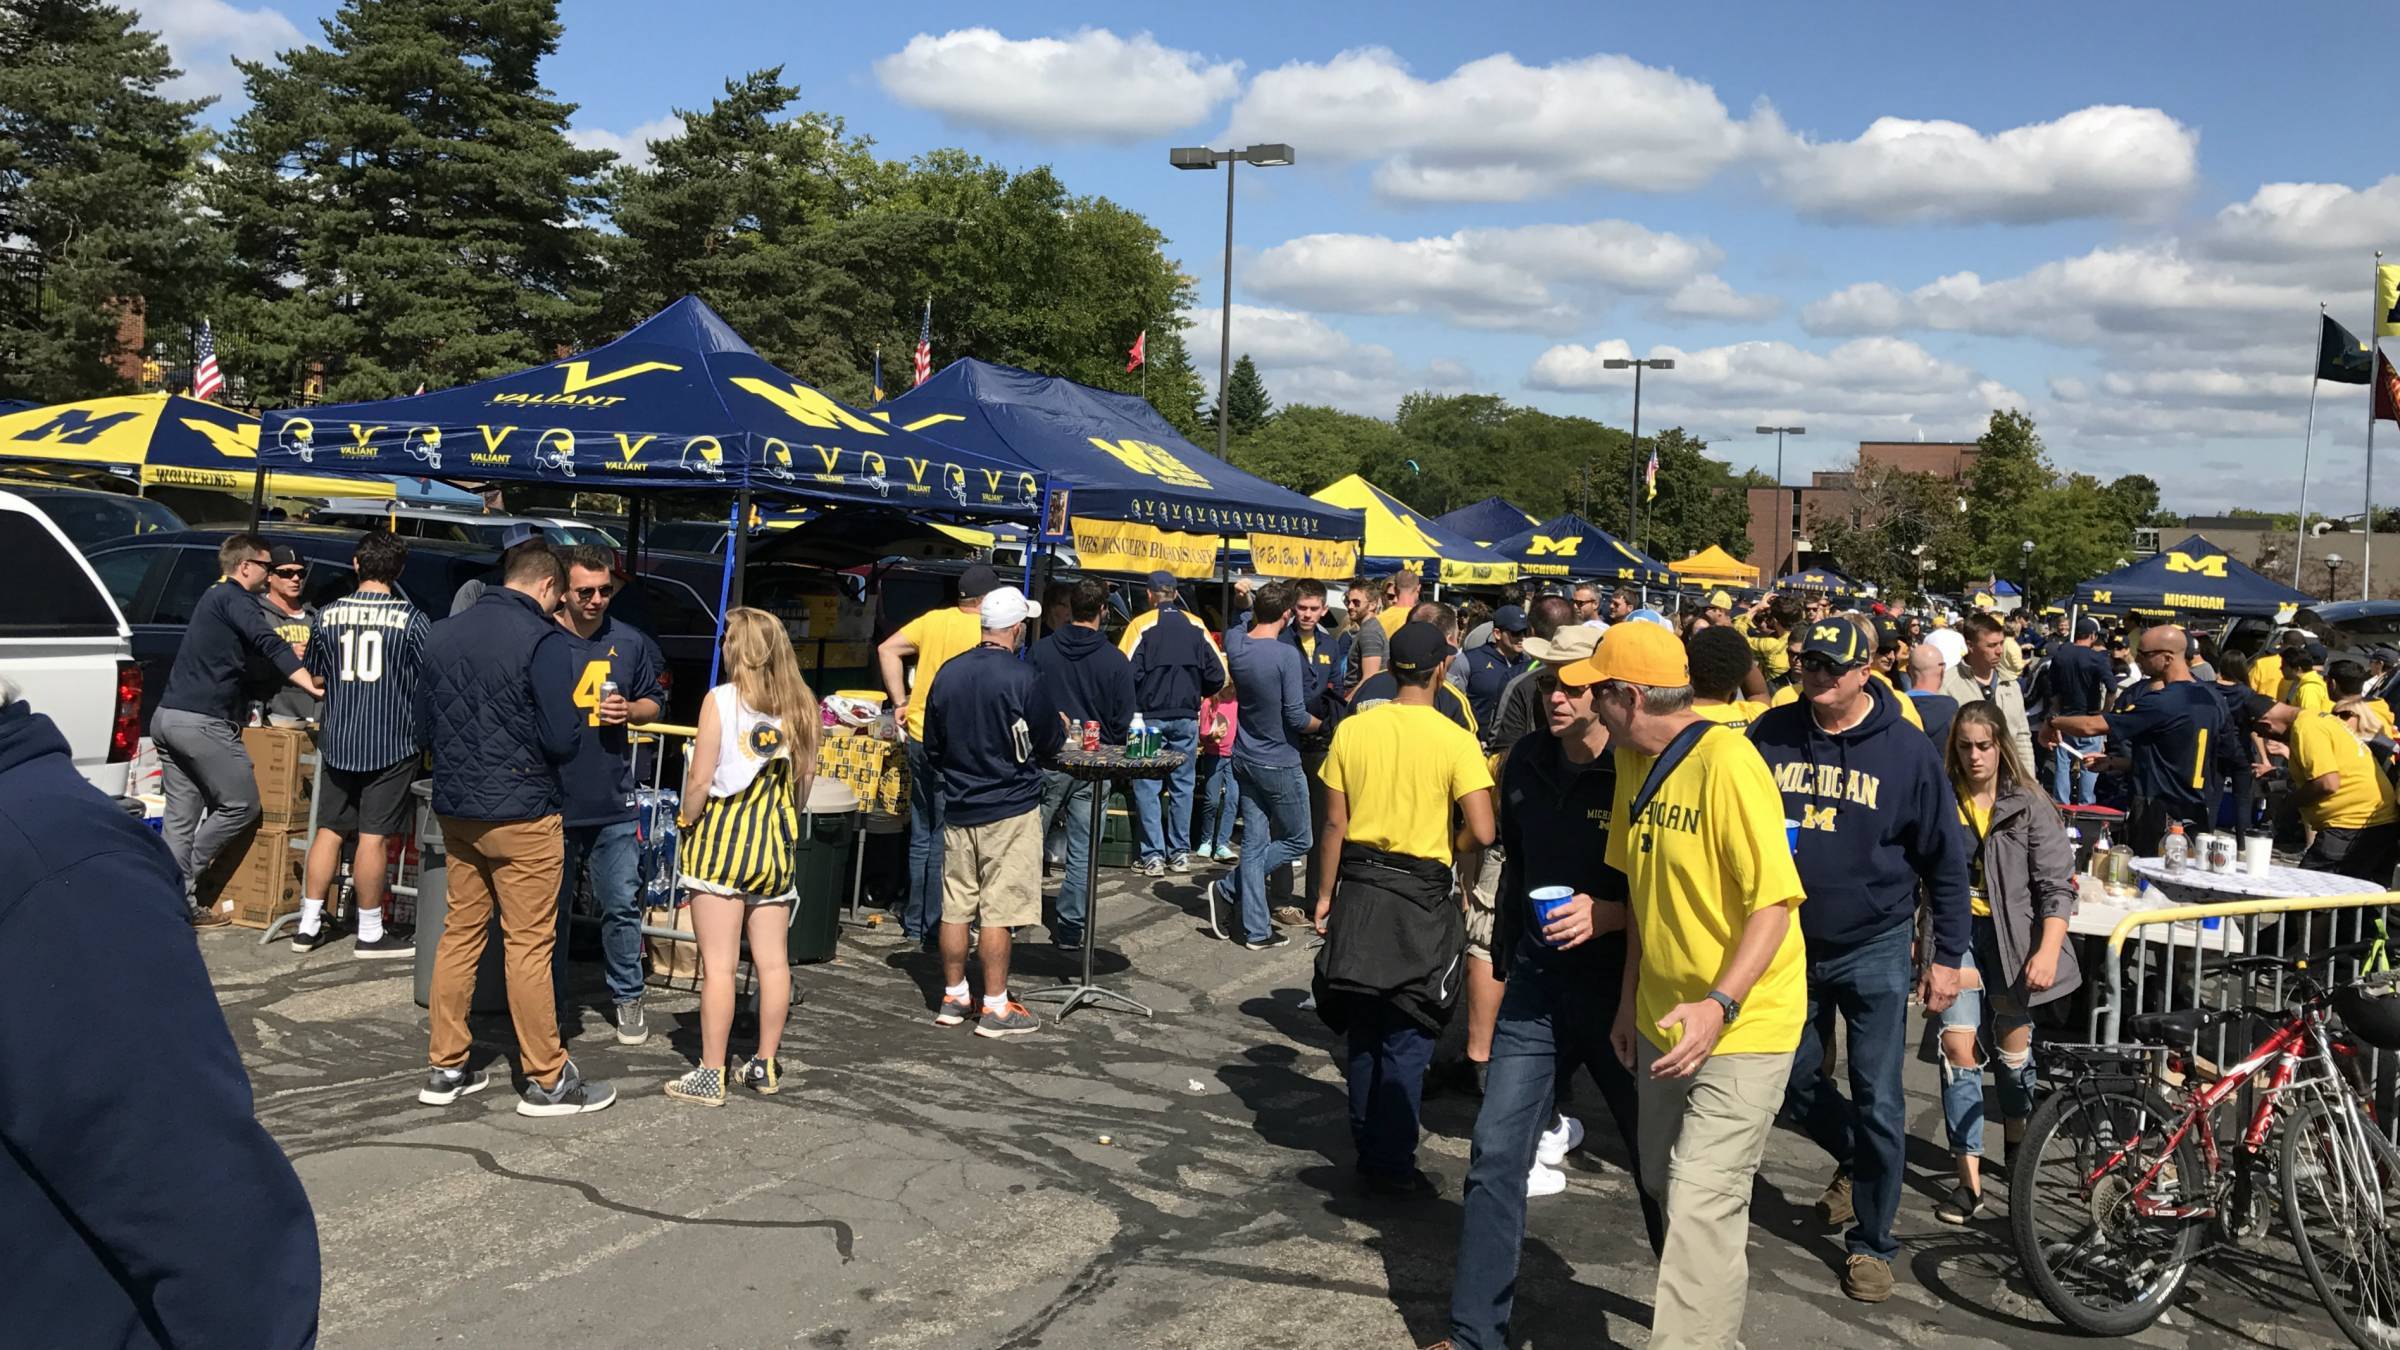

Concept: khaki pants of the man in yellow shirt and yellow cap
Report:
left=1634, top=1035, right=1793, bottom=1350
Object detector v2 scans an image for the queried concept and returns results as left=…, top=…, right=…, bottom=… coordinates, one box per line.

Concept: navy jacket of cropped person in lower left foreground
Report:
left=0, top=701, right=319, bottom=1350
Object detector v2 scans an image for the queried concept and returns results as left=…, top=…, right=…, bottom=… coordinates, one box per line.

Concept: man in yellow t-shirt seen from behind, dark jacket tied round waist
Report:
left=1315, top=622, right=1493, bottom=1199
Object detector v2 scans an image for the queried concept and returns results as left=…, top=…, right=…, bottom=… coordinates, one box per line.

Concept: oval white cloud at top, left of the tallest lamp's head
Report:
left=876, top=29, right=1241, bottom=142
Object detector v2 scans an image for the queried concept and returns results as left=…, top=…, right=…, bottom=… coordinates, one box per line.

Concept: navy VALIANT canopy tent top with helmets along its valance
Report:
left=259, top=295, right=1042, bottom=519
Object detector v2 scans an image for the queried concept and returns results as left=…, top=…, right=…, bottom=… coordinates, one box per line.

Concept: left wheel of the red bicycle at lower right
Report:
left=2009, top=1083, right=2208, bottom=1336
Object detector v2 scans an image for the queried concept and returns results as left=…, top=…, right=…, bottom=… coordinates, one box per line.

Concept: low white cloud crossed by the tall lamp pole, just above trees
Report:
left=1183, top=305, right=1476, bottom=418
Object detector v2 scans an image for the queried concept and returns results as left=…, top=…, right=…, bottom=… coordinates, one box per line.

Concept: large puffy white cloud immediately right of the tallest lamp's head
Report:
left=1226, top=48, right=1783, bottom=202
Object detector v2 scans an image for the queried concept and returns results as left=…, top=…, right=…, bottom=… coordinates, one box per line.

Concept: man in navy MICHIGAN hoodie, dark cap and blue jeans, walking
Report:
left=1750, top=615, right=1970, bottom=1302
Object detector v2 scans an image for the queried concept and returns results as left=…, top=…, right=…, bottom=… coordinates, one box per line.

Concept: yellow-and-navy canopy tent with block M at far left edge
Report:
left=0, top=394, right=398, bottom=497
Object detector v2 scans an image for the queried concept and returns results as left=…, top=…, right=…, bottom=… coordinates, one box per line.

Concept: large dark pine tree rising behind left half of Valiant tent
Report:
left=214, top=0, right=610, bottom=399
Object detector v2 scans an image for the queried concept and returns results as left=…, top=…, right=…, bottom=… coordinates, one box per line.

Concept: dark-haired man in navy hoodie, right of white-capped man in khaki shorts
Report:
left=1027, top=577, right=1133, bottom=946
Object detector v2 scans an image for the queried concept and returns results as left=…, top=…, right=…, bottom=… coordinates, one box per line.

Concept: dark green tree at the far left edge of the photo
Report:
left=0, top=0, right=216, bottom=401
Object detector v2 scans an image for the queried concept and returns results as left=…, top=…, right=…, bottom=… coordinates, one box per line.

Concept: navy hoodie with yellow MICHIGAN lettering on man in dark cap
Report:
left=1750, top=680, right=1970, bottom=966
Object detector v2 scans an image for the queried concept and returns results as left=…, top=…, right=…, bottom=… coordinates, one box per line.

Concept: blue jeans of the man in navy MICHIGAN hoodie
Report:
left=1783, top=922, right=1915, bottom=1261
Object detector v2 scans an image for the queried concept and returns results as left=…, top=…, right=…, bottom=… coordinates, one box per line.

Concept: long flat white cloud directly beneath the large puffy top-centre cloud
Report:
left=1241, top=221, right=1723, bottom=331
